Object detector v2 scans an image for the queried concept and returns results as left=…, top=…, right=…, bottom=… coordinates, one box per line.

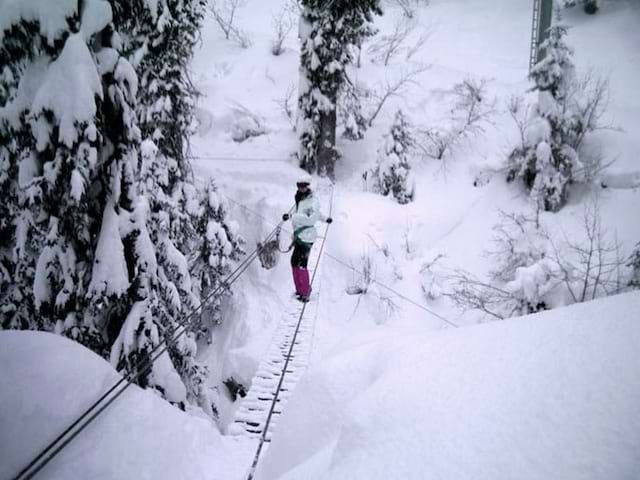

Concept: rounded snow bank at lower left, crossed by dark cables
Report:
left=0, top=331, right=235, bottom=480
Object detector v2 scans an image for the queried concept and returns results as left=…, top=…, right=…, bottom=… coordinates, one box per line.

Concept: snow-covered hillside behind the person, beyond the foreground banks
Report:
left=193, top=0, right=640, bottom=428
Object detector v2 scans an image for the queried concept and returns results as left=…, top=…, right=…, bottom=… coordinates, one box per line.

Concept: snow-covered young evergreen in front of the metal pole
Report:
left=508, top=24, right=582, bottom=211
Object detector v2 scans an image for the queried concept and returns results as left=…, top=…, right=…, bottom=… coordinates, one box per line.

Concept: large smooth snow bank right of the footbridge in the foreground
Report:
left=258, top=292, right=640, bottom=480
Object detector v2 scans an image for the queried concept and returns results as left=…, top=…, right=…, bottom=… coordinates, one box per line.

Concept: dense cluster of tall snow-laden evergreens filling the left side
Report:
left=0, top=0, right=238, bottom=412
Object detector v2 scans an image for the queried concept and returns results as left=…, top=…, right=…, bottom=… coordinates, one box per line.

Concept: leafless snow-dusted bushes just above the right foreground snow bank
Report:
left=445, top=200, right=625, bottom=318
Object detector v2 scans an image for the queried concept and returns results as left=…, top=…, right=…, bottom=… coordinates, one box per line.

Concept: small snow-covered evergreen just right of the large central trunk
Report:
left=373, top=110, right=414, bottom=204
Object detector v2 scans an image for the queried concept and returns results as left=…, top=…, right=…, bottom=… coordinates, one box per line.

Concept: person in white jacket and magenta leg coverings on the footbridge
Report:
left=282, top=175, right=333, bottom=302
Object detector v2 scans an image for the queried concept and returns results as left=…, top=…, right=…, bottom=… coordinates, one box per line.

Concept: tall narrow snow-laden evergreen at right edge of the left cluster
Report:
left=110, top=0, right=241, bottom=412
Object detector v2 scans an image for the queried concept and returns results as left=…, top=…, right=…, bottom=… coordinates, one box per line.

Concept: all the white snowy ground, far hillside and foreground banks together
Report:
left=0, top=0, right=640, bottom=480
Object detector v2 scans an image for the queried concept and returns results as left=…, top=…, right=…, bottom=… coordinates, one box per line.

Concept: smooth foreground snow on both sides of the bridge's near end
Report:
left=0, top=292, right=640, bottom=480
